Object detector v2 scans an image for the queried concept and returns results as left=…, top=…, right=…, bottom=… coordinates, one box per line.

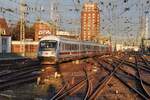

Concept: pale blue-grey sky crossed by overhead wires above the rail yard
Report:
left=0, top=0, right=150, bottom=40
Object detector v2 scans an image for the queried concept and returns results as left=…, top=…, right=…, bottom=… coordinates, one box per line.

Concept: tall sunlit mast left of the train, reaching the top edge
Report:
left=20, top=0, right=25, bottom=56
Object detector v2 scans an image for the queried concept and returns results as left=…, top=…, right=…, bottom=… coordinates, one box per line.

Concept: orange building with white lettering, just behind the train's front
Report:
left=34, top=21, right=56, bottom=41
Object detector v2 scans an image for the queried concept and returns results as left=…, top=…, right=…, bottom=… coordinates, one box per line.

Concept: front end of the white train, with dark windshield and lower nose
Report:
left=38, top=40, right=58, bottom=64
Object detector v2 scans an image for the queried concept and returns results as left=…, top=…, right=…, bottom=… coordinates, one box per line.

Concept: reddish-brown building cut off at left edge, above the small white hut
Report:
left=0, top=18, right=8, bottom=35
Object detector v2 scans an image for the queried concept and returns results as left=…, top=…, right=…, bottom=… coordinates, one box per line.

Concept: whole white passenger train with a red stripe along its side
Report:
left=38, top=36, right=109, bottom=64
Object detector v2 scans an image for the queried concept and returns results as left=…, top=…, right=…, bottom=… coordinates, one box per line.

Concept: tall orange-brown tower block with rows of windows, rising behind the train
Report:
left=80, top=3, right=100, bottom=41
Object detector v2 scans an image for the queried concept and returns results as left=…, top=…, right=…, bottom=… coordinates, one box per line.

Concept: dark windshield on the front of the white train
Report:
left=40, top=40, right=57, bottom=50
